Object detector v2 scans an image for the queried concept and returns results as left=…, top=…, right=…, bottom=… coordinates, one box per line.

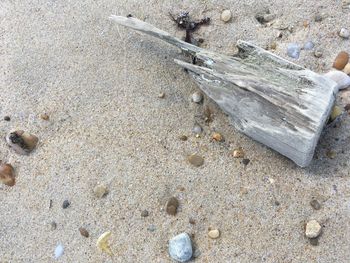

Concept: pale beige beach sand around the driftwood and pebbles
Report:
left=0, top=0, right=350, bottom=263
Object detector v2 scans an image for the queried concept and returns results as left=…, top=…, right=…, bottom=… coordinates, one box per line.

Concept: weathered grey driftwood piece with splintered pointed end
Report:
left=111, top=15, right=338, bottom=167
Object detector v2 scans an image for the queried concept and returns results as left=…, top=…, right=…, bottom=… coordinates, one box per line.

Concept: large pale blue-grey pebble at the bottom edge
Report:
left=169, top=233, right=193, bottom=262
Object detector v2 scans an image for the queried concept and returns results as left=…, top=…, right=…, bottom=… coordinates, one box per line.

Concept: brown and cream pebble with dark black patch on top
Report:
left=6, top=130, right=38, bottom=155
